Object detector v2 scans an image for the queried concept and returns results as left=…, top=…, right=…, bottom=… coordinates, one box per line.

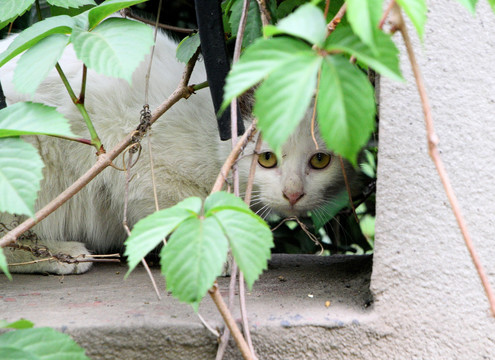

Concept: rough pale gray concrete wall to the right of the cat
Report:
left=371, top=0, right=495, bottom=359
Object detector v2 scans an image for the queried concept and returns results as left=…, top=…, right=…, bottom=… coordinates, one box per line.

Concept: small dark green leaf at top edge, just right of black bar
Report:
left=229, top=0, right=262, bottom=47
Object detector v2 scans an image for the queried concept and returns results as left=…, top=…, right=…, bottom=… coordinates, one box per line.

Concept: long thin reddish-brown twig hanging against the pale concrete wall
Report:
left=392, top=4, right=495, bottom=317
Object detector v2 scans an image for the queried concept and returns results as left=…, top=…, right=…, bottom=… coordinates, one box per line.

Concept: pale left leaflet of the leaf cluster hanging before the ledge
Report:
left=124, top=197, right=201, bottom=276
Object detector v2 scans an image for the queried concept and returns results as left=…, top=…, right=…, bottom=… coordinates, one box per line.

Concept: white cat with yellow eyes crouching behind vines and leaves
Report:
left=0, top=28, right=354, bottom=274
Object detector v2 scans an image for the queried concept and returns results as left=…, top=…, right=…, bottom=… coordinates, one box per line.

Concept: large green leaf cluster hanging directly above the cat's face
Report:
left=223, top=2, right=402, bottom=164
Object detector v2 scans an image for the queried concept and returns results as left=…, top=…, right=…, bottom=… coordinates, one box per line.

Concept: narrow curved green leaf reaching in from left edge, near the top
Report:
left=0, top=15, right=74, bottom=67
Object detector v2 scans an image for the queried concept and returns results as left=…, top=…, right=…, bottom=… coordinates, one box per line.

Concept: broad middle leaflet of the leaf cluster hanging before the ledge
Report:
left=161, top=217, right=228, bottom=311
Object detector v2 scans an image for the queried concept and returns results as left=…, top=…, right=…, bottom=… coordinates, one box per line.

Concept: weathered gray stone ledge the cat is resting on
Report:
left=0, top=254, right=372, bottom=360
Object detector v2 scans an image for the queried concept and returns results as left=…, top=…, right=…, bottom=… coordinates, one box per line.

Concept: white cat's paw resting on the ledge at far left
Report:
left=5, top=241, right=92, bottom=275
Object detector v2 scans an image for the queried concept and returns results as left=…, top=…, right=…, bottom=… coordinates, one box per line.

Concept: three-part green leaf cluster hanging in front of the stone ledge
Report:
left=124, top=191, right=273, bottom=310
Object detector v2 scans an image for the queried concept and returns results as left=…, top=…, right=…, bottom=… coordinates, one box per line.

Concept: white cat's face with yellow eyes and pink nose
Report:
left=239, top=119, right=356, bottom=217
